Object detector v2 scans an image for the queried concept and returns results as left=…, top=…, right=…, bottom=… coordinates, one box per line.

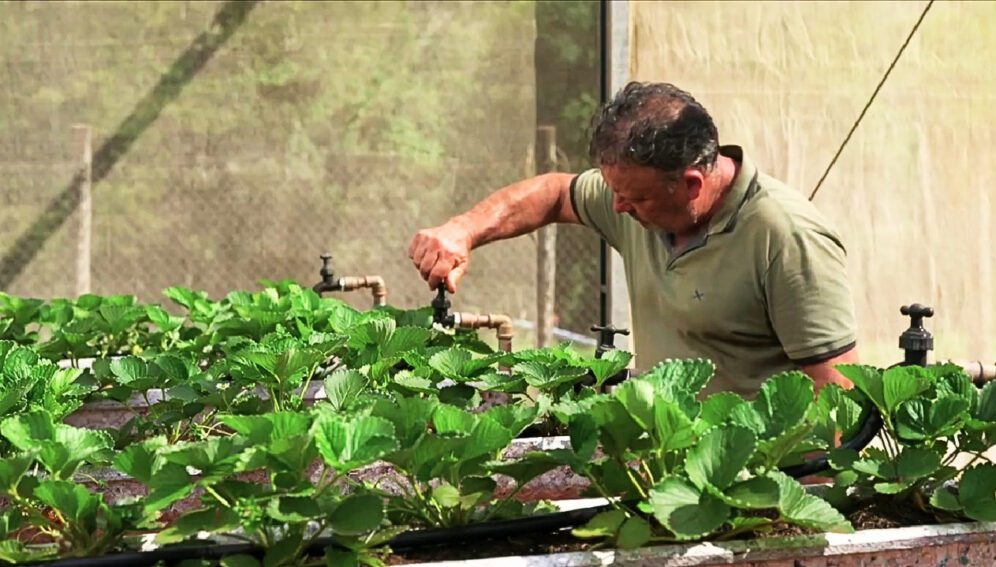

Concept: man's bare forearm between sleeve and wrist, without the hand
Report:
left=450, top=173, right=577, bottom=248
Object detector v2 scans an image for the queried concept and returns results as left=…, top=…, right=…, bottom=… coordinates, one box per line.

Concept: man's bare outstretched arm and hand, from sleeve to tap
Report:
left=408, top=173, right=580, bottom=293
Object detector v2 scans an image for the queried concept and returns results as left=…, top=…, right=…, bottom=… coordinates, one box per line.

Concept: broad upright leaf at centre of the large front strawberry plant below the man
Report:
left=685, top=426, right=756, bottom=490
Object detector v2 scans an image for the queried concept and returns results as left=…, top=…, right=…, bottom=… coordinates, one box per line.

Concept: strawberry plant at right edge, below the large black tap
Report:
left=830, top=365, right=996, bottom=521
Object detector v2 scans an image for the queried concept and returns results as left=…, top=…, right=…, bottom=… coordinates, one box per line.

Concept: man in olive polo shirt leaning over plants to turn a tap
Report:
left=408, top=82, right=856, bottom=397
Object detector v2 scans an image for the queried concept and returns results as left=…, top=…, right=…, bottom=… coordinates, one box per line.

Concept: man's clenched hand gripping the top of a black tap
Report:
left=408, top=219, right=472, bottom=293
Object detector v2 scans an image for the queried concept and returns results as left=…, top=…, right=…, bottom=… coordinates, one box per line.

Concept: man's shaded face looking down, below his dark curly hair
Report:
left=601, top=165, right=701, bottom=233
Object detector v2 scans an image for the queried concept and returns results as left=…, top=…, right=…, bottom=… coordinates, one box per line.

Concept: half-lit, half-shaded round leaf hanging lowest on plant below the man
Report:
left=649, top=477, right=730, bottom=539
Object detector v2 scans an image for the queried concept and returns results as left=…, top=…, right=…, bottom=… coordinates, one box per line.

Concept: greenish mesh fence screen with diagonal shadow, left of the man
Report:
left=0, top=1, right=598, bottom=346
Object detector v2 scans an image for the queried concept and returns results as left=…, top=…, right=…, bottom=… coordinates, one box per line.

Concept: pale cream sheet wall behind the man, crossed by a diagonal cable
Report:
left=630, top=2, right=996, bottom=364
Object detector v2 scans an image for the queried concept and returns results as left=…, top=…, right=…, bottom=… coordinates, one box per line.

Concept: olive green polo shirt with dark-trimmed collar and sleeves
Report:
left=571, top=146, right=856, bottom=397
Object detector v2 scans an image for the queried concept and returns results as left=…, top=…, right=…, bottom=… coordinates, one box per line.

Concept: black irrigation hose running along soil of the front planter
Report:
left=25, top=406, right=882, bottom=567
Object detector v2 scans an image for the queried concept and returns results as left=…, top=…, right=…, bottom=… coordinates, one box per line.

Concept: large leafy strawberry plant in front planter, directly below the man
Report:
left=506, top=360, right=852, bottom=547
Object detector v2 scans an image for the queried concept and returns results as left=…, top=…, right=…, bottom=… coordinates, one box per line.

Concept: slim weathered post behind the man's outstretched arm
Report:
left=536, top=126, right=557, bottom=348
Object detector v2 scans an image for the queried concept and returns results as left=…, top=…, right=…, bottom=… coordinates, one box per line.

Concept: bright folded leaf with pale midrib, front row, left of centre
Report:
left=313, top=413, right=398, bottom=473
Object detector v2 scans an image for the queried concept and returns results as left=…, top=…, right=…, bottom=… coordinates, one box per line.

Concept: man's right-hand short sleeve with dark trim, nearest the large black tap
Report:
left=765, top=229, right=857, bottom=365
